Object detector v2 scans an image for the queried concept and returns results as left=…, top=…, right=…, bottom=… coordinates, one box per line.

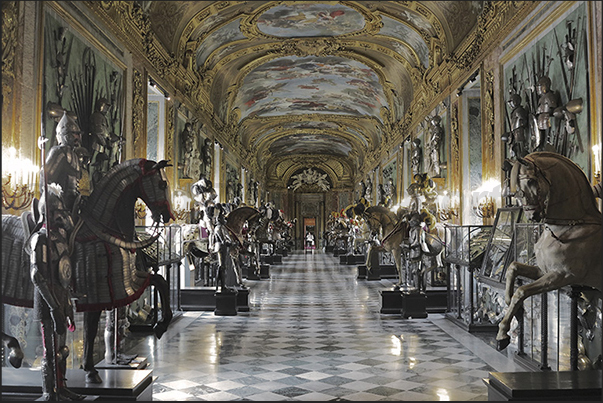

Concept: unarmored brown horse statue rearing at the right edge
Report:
left=496, top=151, right=602, bottom=350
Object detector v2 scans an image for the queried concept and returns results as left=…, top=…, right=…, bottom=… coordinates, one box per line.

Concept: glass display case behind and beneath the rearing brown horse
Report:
left=511, top=223, right=602, bottom=371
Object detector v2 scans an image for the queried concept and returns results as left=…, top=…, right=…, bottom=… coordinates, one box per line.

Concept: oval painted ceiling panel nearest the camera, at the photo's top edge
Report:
left=257, top=2, right=364, bottom=37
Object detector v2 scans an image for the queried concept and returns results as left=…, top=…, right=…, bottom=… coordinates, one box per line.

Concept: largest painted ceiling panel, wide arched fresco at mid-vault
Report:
left=234, top=56, right=388, bottom=119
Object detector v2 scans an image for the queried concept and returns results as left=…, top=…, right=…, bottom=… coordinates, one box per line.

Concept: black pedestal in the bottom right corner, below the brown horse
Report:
left=482, top=370, right=603, bottom=402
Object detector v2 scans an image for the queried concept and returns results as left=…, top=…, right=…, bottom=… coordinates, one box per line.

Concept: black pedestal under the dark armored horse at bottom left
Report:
left=2, top=367, right=154, bottom=401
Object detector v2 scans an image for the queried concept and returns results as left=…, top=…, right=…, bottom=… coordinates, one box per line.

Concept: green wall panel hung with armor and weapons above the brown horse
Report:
left=503, top=3, right=592, bottom=175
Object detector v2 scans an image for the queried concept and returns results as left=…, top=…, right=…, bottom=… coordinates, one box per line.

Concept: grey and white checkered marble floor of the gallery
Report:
left=122, top=251, right=521, bottom=401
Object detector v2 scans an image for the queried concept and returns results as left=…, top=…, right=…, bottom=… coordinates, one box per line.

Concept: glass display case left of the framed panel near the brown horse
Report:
left=444, top=224, right=492, bottom=332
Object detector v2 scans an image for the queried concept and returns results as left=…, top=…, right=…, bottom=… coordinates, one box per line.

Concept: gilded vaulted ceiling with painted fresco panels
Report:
left=133, top=1, right=482, bottom=188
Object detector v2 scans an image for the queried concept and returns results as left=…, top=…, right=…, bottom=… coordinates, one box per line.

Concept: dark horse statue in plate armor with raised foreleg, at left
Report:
left=2, top=159, right=174, bottom=383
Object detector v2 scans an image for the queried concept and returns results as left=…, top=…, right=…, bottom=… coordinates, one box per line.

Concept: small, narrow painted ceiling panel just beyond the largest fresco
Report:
left=269, top=133, right=352, bottom=157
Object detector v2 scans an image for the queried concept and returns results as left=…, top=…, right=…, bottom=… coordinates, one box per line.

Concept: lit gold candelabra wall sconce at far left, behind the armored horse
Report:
left=2, top=147, right=39, bottom=210
